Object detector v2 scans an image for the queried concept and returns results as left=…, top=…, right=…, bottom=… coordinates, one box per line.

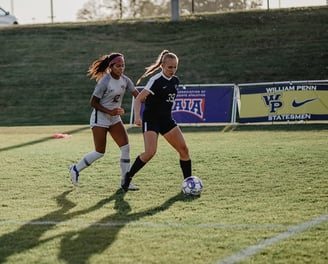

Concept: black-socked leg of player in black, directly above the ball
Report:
left=163, top=126, right=192, bottom=178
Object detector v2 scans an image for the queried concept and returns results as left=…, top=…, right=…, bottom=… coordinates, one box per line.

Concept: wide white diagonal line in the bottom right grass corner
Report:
left=217, top=215, right=328, bottom=264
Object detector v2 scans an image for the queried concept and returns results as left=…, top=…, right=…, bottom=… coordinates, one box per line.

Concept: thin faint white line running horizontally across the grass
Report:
left=0, top=220, right=287, bottom=230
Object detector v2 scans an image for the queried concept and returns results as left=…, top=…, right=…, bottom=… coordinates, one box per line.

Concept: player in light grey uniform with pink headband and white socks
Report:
left=69, top=53, right=139, bottom=190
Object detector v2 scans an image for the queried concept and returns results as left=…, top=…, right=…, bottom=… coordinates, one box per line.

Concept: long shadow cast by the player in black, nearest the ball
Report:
left=59, top=190, right=191, bottom=264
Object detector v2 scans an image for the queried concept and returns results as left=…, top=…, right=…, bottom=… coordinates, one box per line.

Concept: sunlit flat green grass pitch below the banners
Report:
left=0, top=124, right=328, bottom=264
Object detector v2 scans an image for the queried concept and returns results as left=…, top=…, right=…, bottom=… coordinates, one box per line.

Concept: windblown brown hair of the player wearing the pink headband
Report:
left=87, top=53, right=123, bottom=81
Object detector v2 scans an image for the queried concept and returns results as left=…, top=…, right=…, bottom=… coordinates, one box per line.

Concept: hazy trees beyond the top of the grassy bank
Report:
left=77, top=0, right=263, bottom=21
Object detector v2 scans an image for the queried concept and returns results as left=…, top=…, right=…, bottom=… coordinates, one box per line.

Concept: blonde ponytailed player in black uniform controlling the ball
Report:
left=121, top=50, right=191, bottom=191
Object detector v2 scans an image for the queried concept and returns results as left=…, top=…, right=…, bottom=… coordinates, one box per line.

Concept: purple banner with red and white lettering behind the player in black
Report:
left=172, top=85, right=233, bottom=123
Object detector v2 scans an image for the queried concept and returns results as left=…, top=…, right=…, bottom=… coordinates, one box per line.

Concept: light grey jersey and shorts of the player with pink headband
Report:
left=90, top=74, right=135, bottom=127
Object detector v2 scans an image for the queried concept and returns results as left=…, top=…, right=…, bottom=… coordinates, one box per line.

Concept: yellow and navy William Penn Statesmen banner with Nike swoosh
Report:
left=238, top=82, right=328, bottom=123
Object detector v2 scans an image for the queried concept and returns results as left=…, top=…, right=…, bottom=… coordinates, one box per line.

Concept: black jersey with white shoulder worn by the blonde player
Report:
left=143, top=72, right=179, bottom=120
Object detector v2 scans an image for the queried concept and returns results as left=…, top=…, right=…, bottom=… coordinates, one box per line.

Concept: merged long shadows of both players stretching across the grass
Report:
left=0, top=189, right=195, bottom=264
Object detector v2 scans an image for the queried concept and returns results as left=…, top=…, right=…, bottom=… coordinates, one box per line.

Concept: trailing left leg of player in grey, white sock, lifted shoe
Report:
left=70, top=126, right=107, bottom=185
